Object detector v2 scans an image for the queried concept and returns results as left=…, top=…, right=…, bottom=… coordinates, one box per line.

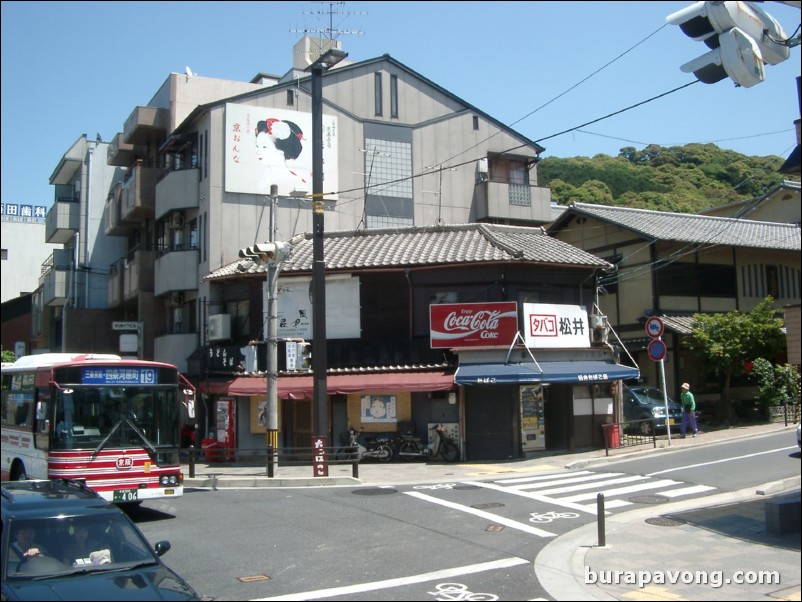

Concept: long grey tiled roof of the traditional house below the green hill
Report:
left=549, top=203, right=802, bottom=251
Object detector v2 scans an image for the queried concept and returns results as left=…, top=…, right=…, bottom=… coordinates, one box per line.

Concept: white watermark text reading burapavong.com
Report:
left=585, top=566, right=781, bottom=588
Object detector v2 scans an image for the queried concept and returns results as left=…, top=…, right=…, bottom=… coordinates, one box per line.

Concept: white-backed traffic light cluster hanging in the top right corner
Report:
left=666, top=1, right=790, bottom=88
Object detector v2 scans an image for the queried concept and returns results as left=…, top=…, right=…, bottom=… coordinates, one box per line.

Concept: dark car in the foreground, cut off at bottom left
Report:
left=0, top=479, right=200, bottom=601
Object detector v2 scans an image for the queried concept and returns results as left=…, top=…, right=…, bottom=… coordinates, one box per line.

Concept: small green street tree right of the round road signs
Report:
left=685, top=297, right=785, bottom=424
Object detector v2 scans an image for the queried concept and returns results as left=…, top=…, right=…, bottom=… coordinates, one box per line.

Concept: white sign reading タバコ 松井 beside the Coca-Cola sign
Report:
left=523, top=303, right=590, bottom=349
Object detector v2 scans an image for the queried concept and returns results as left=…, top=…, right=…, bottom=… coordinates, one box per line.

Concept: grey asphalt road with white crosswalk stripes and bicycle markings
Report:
left=132, top=433, right=799, bottom=600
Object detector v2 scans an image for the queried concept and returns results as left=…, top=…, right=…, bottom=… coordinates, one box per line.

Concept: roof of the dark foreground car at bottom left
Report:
left=1, top=479, right=120, bottom=521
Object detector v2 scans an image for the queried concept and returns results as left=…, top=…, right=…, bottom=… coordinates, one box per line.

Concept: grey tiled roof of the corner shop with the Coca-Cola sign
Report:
left=206, top=224, right=609, bottom=280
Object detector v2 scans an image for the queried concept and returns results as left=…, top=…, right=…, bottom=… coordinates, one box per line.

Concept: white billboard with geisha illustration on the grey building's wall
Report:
left=225, top=103, right=338, bottom=200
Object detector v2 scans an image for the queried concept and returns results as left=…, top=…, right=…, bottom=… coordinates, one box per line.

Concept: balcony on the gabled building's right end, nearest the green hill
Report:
left=475, top=180, right=551, bottom=224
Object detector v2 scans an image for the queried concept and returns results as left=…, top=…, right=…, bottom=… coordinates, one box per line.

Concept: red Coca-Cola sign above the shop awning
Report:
left=429, top=301, right=518, bottom=349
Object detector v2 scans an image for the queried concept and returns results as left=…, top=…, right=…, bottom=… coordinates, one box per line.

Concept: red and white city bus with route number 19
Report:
left=0, top=353, right=195, bottom=503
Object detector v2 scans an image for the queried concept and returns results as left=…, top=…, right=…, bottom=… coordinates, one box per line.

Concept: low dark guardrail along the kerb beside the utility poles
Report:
left=180, top=446, right=359, bottom=479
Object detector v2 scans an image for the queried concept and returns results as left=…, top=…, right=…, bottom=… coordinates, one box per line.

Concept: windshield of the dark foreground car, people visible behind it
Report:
left=3, top=513, right=159, bottom=580
